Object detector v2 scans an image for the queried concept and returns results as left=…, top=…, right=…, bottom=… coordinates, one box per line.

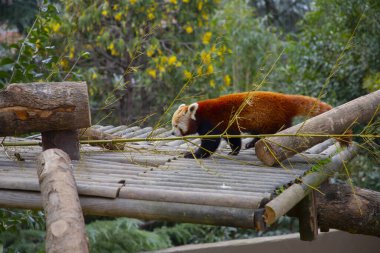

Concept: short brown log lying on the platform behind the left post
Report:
left=79, top=128, right=125, bottom=150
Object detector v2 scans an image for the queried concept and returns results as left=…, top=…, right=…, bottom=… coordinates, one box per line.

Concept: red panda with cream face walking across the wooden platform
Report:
left=172, top=91, right=344, bottom=158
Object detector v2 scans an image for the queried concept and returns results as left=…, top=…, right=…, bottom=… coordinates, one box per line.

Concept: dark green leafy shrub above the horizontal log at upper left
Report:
left=0, top=0, right=83, bottom=87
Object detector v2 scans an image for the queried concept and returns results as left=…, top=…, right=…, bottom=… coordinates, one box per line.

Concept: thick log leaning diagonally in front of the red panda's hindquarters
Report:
left=255, top=90, right=380, bottom=166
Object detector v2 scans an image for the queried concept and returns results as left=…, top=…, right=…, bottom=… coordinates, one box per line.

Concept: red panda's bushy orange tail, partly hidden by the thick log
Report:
left=290, top=95, right=352, bottom=146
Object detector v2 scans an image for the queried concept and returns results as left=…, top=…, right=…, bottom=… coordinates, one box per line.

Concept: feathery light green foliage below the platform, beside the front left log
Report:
left=87, top=218, right=171, bottom=252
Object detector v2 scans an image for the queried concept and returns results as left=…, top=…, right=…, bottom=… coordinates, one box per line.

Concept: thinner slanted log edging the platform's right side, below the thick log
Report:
left=265, top=146, right=356, bottom=224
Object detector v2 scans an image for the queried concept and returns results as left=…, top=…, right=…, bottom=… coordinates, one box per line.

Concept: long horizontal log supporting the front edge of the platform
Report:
left=0, top=189, right=254, bottom=229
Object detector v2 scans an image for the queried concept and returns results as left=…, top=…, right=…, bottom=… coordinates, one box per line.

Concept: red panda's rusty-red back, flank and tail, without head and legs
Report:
left=196, top=91, right=332, bottom=134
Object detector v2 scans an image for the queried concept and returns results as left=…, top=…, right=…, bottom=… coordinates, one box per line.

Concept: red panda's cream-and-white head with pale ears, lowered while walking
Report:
left=172, top=103, right=198, bottom=136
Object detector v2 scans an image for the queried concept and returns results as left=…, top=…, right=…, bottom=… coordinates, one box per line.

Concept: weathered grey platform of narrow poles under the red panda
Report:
left=0, top=126, right=351, bottom=228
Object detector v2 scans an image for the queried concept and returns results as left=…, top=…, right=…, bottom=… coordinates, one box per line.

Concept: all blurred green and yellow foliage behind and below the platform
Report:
left=0, top=0, right=380, bottom=252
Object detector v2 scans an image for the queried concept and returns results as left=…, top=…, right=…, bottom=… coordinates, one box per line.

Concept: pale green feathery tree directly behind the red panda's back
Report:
left=212, top=0, right=284, bottom=93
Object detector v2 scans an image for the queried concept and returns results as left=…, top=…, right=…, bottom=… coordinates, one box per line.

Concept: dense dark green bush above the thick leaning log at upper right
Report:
left=274, top=0, right=380, bottom=104
